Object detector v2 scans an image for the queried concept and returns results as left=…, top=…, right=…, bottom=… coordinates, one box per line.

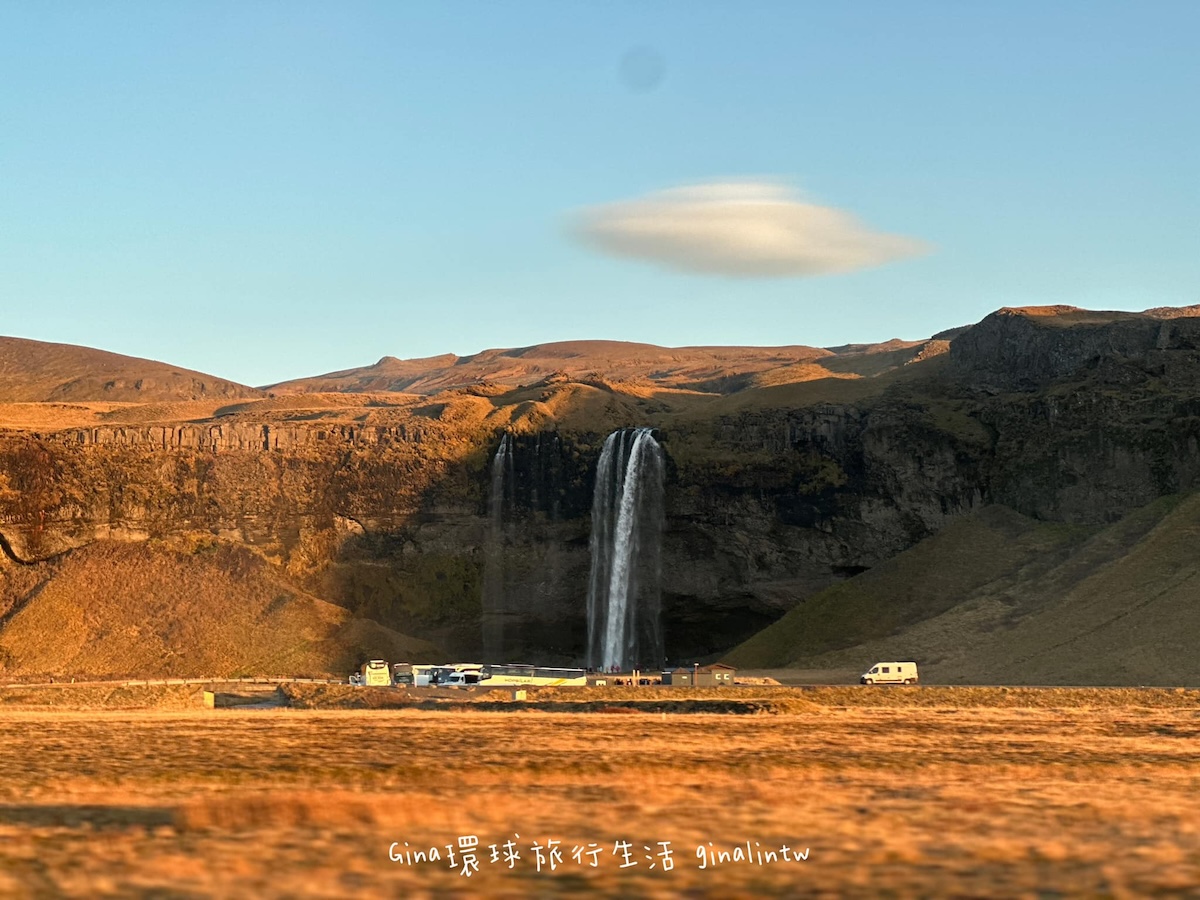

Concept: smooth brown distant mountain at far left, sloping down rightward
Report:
left=0, top=337, right=264, bottom=403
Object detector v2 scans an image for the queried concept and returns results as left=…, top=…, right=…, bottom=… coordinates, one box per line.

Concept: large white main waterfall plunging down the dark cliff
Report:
left=587, top=428, right=664, bottom=668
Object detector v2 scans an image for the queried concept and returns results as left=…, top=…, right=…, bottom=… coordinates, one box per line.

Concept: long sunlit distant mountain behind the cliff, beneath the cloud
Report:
left=265, top=341, right=944, bottom=394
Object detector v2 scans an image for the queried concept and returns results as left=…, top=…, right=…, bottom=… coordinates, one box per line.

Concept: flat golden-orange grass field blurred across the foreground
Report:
left=0, top=688, right=1200, bottom=898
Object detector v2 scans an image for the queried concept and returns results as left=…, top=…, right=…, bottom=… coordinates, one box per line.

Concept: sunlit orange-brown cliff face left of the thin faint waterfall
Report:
left=0, top=422, right=492, bottom=652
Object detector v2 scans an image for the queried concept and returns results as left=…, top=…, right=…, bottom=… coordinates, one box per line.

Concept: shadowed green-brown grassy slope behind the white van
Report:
left=727, top=496, right=1200, bottom=685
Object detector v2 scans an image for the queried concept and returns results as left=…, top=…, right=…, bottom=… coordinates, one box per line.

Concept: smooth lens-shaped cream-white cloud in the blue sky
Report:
left=574, top=182, right=928, bottom=277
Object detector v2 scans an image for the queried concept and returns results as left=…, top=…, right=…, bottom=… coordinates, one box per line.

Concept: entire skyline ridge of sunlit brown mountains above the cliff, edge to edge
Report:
left=0, top=305, right=1200, bottom=403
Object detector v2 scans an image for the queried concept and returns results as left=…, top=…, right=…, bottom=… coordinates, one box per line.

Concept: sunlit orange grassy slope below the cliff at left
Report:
left=0, top=544, right=437, bottom=677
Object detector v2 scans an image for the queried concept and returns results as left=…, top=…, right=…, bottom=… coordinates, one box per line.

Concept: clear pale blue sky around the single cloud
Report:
left=0, top=0, right=1200, bottom=384
